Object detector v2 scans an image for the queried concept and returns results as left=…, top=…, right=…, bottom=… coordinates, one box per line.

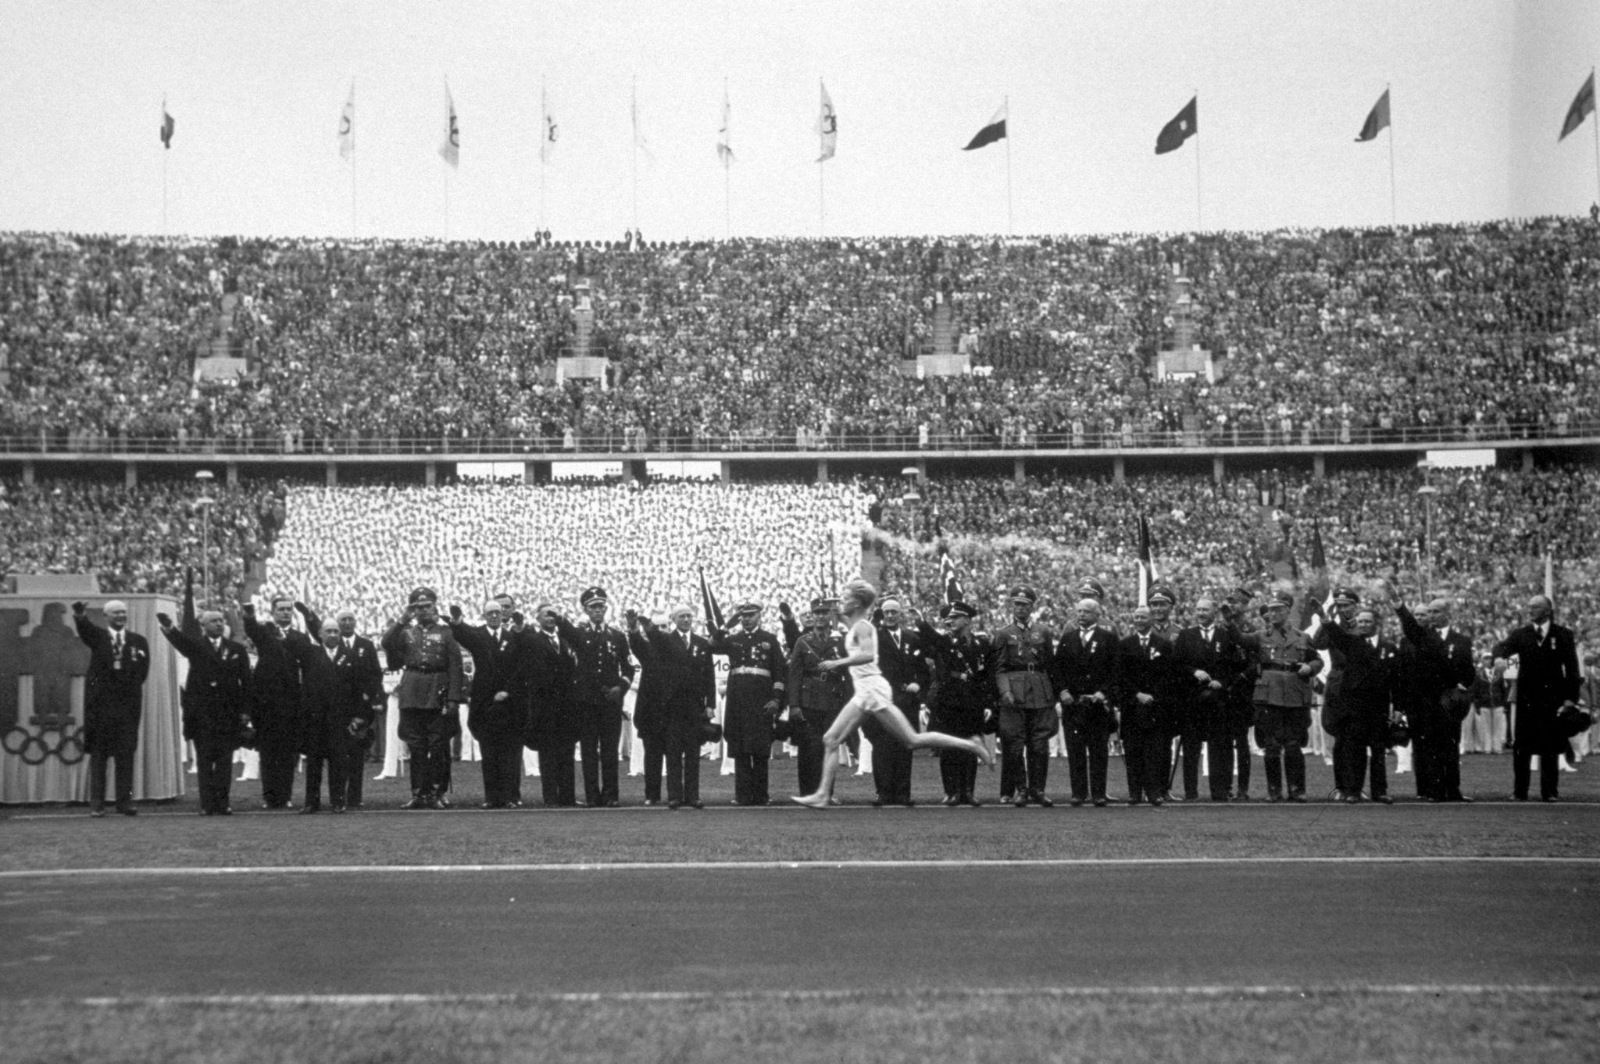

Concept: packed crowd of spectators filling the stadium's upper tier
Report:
left=0, top=219, right=1600, bottom=450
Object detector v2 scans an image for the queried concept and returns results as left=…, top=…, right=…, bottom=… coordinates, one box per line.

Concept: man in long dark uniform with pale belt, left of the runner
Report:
left=712, top=602, right=786, bottom=805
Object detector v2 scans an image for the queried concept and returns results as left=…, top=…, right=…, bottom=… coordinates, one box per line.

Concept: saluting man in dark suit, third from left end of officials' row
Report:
left=243, top=595, right=310, bottom=810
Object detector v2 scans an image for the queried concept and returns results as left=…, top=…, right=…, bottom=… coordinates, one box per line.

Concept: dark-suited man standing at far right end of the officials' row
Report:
left=1494, top=595, right=1582, bottom=802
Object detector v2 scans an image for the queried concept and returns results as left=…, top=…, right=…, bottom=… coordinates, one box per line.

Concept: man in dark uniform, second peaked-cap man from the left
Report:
left=555, top=587, right=634, bottom=808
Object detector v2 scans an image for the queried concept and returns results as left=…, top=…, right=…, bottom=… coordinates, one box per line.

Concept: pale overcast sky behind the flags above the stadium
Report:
left=0, top=0, right=1600, bottom=238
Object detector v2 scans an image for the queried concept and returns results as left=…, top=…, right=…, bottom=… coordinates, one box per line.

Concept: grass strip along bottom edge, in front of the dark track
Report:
left=0, top=989, right=1600, bottom=1064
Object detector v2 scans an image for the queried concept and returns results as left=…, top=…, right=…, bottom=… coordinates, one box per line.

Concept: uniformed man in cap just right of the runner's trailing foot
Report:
left=989, top=587, right=1061, bottom=810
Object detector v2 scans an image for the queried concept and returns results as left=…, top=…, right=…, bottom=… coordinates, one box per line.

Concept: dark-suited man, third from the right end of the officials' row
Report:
left=1312, top=592, right=1400, bottom=805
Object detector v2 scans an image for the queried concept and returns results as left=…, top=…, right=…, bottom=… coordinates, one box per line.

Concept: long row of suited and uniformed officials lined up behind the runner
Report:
left=74, top=579, right=1581, bottom=816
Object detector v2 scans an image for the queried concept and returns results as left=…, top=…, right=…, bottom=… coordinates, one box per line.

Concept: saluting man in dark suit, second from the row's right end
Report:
left=1395, top=585, right=1472, bottom=802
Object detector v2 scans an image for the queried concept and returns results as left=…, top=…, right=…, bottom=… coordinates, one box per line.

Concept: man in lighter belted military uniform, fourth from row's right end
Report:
left=1240, top=589, right=1322, bottom=802
